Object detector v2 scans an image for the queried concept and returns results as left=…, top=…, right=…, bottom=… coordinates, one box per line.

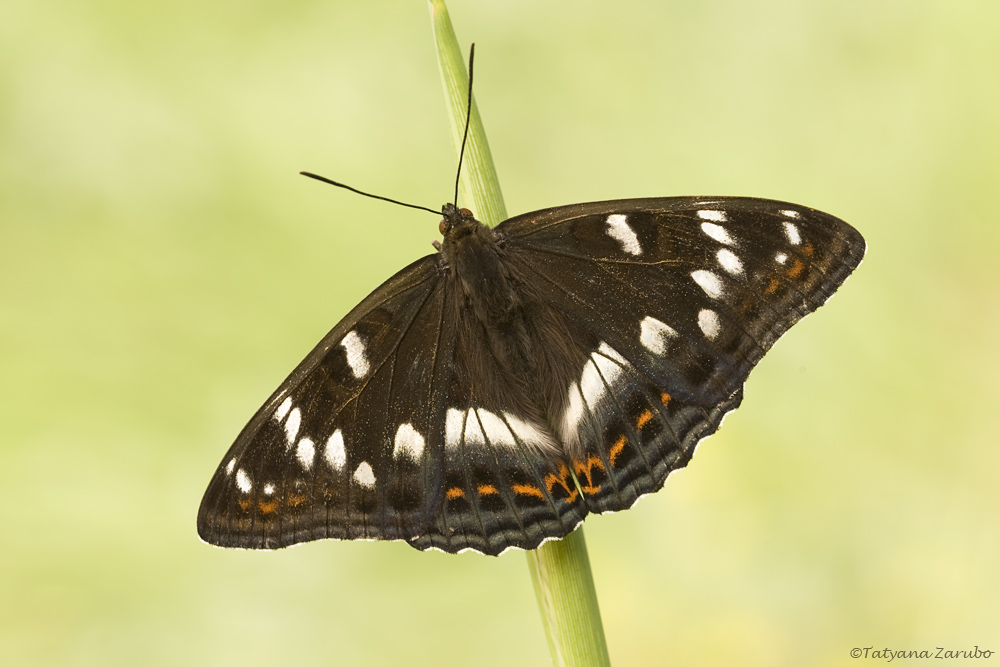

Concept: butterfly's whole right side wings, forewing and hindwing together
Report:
left=497, top=197, right=865, bottom=512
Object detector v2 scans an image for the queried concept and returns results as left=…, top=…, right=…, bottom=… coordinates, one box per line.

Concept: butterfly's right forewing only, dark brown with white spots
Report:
left=496, top=197, right=865, bottom=408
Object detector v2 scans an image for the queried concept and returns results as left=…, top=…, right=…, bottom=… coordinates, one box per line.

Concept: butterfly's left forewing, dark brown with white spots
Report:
left=198, top=256, right=451, bottom=549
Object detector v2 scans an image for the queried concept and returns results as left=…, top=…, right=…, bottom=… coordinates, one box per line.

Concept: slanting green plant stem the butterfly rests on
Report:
left=430, top=0, right=611, bottom=667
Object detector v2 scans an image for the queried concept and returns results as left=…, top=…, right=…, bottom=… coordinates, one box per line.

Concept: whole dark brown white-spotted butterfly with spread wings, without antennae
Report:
left=198, top=197, right=865, bottom=554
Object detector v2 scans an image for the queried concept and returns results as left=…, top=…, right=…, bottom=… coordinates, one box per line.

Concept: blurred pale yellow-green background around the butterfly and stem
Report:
left=0, top=0, right=1000, bottom=666
